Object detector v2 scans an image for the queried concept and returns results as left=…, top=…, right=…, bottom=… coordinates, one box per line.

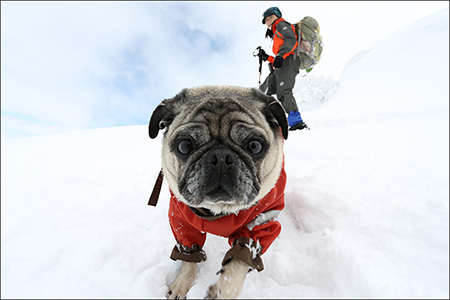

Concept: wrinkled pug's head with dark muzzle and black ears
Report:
left=149, top=86, right=288, bottom=215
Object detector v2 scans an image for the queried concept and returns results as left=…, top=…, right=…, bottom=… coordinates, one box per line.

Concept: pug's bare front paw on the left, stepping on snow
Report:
left=167, top=261, right=197, bottom=299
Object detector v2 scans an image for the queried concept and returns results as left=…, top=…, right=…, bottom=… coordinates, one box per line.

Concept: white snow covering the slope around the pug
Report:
left=1, top=9, right=449, bottom=299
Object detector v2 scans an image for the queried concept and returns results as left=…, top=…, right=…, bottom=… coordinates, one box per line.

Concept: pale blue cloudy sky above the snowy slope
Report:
left=1, top=1, right=448, bottom=139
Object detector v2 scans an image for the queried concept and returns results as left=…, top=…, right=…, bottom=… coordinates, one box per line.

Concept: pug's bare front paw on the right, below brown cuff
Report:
left=206, top=259, right=248, bottom=299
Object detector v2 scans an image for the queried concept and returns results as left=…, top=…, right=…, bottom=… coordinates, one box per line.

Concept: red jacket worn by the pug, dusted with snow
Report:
left=169, top=166, right=286, bottom=253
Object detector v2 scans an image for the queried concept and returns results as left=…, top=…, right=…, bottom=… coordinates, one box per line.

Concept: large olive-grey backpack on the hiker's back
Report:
left=294, top=17, right=323, bottom=72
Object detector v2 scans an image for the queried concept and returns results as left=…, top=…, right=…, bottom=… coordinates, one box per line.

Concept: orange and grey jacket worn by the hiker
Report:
left=267, top=18, right=298, bottom=64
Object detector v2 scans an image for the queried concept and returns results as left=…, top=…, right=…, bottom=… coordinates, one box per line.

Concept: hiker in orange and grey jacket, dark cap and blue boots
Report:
left=259, top=7, right=309, bottom=130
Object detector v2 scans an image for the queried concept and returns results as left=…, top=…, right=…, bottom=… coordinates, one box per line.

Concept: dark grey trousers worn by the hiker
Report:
left=259, top=55, right=300, bottom=113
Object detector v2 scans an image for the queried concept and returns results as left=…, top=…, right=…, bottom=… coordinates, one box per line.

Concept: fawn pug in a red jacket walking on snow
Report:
left=148, top=86, right=288, bottom=299
